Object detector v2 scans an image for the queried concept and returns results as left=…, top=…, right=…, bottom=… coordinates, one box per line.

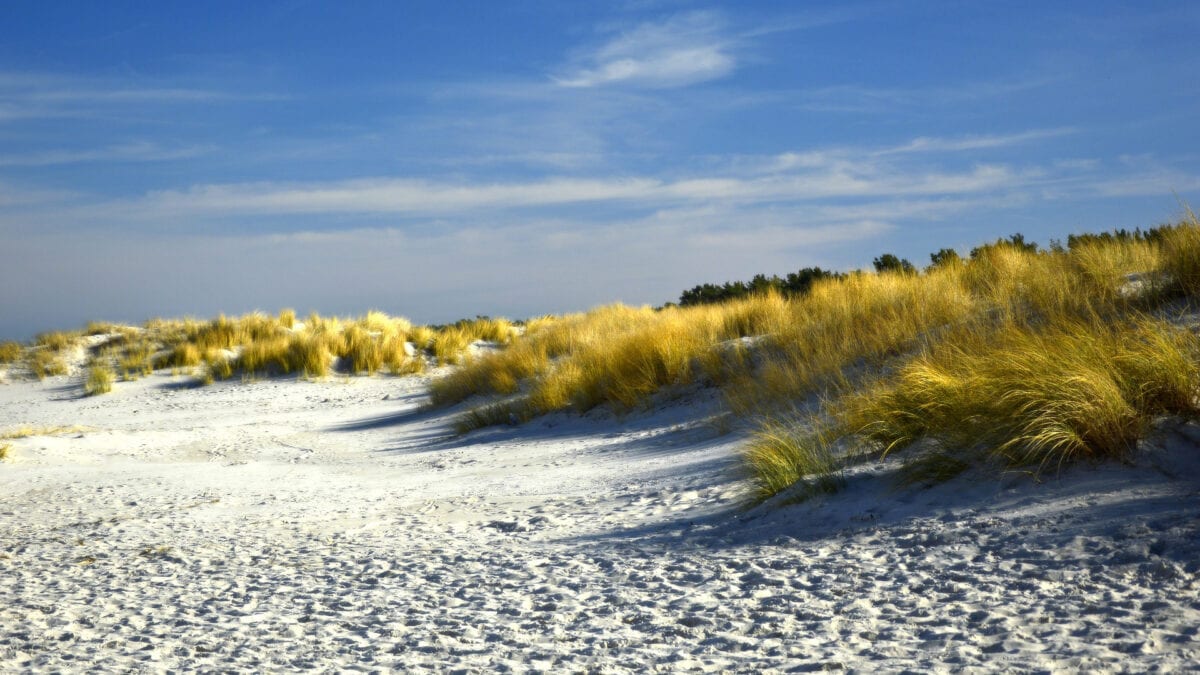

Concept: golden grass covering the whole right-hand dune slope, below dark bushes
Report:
left=431, top=221, right=1200, bottom=498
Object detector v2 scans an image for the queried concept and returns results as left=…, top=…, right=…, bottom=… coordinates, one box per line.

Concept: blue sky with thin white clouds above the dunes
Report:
left=0, top=0, right=1200, bottom=340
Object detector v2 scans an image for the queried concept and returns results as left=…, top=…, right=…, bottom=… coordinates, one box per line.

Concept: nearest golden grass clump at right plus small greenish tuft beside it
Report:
left=746, top=315, right=1200, bottom=497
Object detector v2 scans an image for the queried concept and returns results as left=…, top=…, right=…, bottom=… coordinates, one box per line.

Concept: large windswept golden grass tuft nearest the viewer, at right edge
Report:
left=842, top=317, right=1200, bottom=470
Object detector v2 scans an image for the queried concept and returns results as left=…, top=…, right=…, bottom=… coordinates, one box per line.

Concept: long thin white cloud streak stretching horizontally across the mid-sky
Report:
left=114, top=165, right=1031, bottom=215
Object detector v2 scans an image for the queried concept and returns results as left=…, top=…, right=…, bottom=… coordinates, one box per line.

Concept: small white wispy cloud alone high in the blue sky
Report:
left=554, top=12, right=737, bottom=88
